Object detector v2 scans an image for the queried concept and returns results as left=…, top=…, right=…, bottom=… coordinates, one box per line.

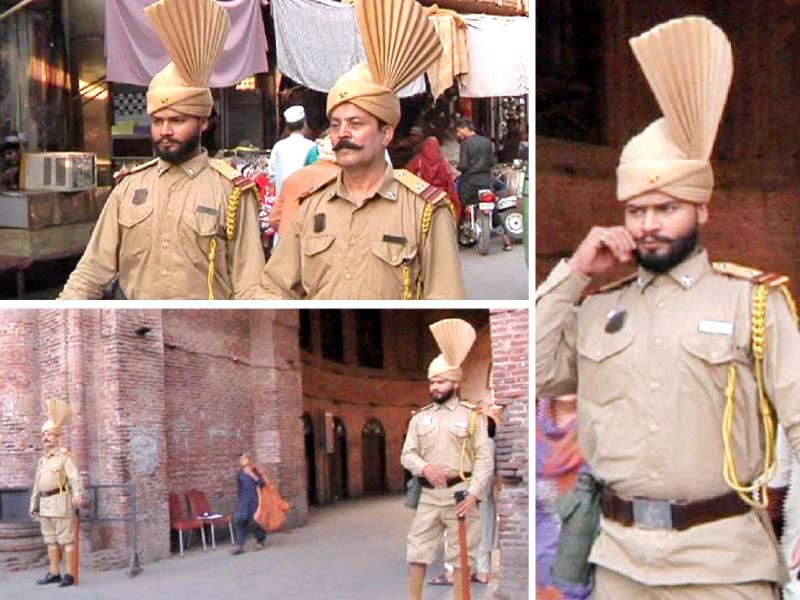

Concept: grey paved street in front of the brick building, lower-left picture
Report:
left=0, top=496, right=494, bottom=600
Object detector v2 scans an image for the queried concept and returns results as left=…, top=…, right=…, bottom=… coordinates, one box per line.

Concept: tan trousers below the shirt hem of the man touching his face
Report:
left=592, top=567, right=780, bottom=600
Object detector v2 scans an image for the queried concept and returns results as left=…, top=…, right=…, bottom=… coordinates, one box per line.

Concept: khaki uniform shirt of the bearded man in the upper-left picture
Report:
left=59, top=150, right=264, bottom=300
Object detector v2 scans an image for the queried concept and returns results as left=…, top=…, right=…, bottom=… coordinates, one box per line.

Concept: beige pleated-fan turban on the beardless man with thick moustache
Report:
left=326, top=0, right=442, bottom=127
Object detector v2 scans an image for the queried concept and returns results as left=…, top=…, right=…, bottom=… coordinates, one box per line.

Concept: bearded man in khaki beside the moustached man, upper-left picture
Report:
left=59, top=0, right=264, bottom=300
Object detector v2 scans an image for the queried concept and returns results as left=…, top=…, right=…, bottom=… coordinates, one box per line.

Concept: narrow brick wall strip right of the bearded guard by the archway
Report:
left=490, top=309, right=529, bottom=600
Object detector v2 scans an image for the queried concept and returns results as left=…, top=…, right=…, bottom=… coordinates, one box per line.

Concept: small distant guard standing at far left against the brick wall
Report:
left=29, top=400, right=84, bottom=587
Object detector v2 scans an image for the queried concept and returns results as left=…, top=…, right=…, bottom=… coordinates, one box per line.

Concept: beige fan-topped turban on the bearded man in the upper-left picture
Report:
left=145, top=0, right=231, bottom=117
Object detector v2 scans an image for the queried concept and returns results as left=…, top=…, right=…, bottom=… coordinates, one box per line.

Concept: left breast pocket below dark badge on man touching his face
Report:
left=577, top=331, right=635, bottom=405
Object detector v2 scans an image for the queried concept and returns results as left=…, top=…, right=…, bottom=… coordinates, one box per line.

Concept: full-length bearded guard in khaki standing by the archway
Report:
left=400, top=319, right=494, bottom=600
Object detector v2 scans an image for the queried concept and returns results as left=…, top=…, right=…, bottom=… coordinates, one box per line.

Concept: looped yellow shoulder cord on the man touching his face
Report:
left=722, top=283, right=798, bottom=508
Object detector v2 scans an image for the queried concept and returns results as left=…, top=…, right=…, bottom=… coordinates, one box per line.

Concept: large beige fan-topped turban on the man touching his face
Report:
left=617, top=17, right=733, bottom=203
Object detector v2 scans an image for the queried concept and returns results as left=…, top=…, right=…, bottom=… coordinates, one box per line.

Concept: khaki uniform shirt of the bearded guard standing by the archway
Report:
left=400, top=396, right=494, bottom=506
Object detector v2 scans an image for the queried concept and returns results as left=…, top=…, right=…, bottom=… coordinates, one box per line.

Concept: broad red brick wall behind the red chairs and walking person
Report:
left=0, top=310, right=307, bottom=568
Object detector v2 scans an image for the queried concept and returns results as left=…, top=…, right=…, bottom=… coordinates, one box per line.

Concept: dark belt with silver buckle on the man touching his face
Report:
left=603, top=488, right=750, bottom=531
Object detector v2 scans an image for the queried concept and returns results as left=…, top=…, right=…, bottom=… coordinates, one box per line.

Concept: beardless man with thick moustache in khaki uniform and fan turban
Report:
left=259, top=0, right=464, bottom=300
